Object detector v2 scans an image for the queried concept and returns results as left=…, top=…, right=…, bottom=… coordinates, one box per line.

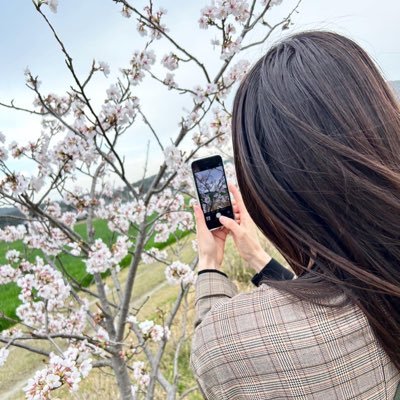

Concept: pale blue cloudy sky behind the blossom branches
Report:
left=0, top=0, right=400, bottom=186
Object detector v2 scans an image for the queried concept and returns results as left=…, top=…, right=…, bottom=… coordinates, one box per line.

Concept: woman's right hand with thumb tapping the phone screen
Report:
left=219, top=183, right=271, bottom=272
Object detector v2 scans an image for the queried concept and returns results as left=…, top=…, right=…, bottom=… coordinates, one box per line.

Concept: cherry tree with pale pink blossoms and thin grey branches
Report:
left=0, top=0, right=300, bottom=400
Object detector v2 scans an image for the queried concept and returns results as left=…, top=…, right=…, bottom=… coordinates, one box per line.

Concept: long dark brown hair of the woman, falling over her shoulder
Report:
left=232, top=31, right=400, bottom=369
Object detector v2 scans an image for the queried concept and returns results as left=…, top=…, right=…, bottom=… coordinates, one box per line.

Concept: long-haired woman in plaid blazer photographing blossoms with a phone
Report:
left=191, top=32, right=400, bottom=400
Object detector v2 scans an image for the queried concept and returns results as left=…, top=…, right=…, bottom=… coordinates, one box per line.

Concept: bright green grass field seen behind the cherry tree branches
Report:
left=0, top=219, right=189, bottom=331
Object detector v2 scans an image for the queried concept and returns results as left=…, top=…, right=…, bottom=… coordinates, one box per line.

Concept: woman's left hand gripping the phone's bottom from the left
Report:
left=193, top=204, right=228, bottom=271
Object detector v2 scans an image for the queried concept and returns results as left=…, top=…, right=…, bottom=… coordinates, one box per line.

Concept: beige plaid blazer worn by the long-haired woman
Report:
left=190, top=272, right=400, bottom=400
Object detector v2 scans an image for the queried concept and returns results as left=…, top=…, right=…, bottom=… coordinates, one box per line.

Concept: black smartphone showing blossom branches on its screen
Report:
left=192, top=155, right=234, bottom=230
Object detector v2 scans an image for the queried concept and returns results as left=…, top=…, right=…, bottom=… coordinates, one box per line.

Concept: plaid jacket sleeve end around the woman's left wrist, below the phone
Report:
left=194, top=272, right=238, bottom=328
